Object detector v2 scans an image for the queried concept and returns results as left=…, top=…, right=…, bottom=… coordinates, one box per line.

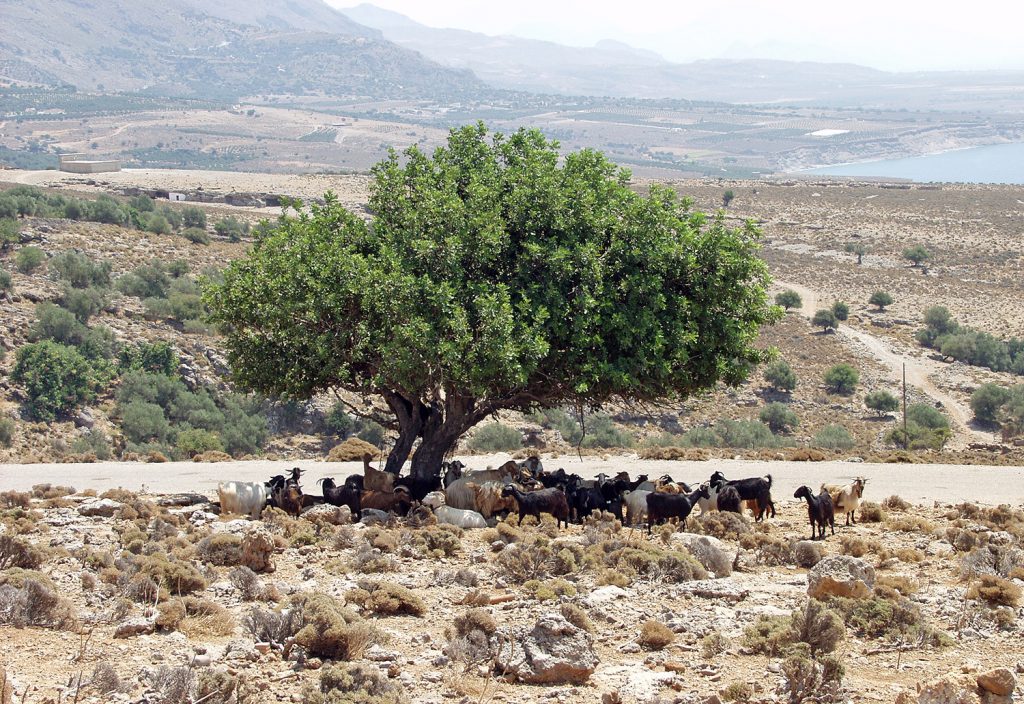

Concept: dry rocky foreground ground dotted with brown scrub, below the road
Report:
left=0, top=487, right=1024, bottom=703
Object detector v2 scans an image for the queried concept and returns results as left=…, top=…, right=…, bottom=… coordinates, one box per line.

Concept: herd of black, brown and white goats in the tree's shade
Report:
left=217, top=454, right=867, bottom=539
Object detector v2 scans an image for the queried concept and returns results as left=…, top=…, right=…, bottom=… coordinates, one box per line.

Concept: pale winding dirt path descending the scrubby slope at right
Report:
left=776, top=281, right=997, bottom=450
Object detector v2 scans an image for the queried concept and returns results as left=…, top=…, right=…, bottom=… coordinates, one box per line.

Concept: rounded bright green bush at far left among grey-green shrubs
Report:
left=11, top=340, right=100, bottom=421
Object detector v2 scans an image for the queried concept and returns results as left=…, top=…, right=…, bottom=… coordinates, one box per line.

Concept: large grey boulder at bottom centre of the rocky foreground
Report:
left=495, top=612, right=598, bottom=685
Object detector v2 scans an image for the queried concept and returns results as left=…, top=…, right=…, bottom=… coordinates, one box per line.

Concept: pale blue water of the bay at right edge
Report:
left=801, top=143, right=1024, bottom=184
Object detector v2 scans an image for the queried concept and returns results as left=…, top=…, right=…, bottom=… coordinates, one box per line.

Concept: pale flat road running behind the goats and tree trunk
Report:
left=0, top=455, right=1024, bottom=505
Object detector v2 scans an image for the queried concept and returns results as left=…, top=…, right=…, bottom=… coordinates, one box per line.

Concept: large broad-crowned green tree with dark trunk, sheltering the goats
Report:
left=206, top=124, right=778, bottom=476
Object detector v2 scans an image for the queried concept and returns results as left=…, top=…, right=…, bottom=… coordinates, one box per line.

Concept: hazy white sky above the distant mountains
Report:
left=329, top=0, right=1024, bottom=71
